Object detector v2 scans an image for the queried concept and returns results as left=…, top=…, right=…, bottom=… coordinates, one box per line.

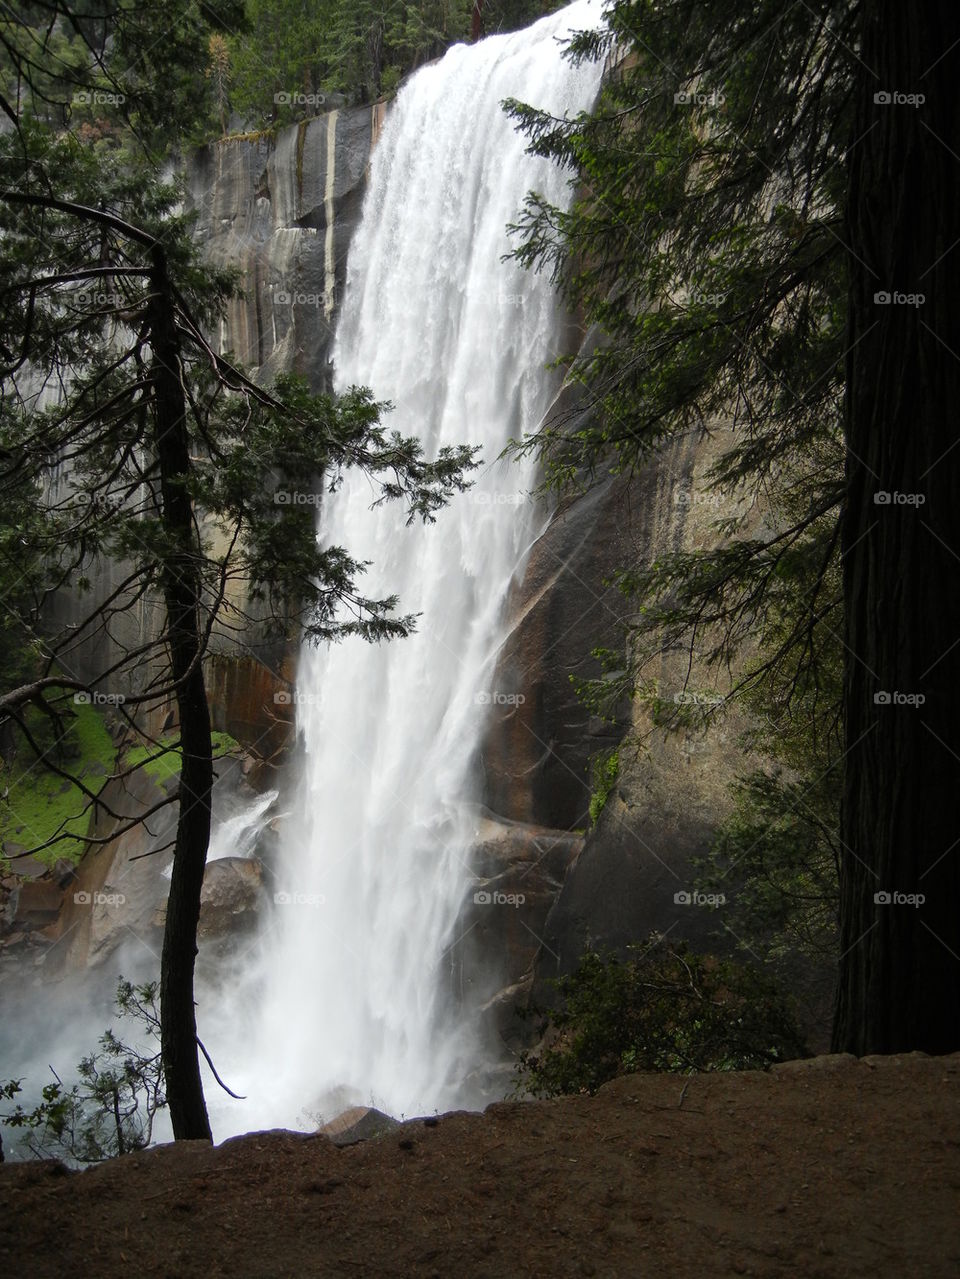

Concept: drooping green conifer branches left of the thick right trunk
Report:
left=507, top=0, right=855, bottom=716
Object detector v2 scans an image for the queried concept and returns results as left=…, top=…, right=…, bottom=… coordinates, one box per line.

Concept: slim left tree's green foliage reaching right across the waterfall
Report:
left=204, top=373, right=474, bottom=641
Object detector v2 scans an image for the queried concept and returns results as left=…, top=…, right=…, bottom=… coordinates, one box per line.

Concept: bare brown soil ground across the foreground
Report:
left=0, top=1054, right=960, bottom=1279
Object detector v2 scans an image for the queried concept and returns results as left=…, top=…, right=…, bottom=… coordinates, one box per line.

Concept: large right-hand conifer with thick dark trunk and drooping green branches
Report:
left=509, top=0, right=960, bottom=1051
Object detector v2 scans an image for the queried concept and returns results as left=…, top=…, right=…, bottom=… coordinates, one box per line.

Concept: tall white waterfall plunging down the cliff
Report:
left=212, top=0, right=600, bottom=1134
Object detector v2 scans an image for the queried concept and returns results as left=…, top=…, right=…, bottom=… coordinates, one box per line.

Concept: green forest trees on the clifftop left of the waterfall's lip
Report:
left=0, top=0, right=559, bottom=138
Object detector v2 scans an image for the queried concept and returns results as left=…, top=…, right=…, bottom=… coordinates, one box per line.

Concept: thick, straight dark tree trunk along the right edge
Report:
left=833, top=0, right=960, bottom=1054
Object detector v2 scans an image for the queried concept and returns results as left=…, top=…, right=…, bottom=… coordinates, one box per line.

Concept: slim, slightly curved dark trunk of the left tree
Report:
left=151, top=246, right=213, bottom=1140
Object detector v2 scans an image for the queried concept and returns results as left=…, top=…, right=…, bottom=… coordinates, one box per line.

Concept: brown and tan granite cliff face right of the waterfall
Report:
left=470, top=388, right=747, bottom=1028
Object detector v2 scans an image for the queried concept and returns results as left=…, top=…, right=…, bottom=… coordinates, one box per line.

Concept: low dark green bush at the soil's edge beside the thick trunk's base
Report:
left=518, top=936, right=805, bottom=1097
